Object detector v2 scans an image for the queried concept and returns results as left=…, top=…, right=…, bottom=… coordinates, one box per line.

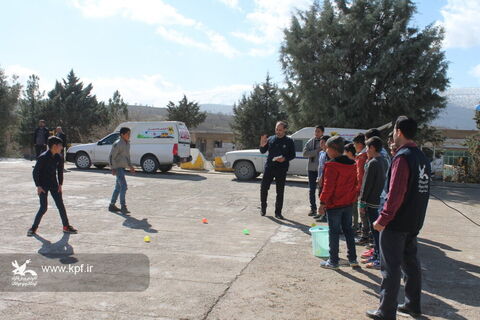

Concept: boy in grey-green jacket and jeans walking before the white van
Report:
left=108, top=127, right=135, bottom=215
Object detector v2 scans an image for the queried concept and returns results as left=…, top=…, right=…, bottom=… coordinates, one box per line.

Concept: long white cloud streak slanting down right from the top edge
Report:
left=72, top=0, right=239, bottom=58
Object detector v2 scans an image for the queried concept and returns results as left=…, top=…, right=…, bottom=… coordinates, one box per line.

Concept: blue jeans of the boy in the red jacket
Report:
left=327, top=206, right=357, bottom=264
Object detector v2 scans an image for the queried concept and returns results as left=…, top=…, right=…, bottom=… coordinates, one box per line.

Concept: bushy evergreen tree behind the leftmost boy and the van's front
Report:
left=42, top=70, right=110, bottom=142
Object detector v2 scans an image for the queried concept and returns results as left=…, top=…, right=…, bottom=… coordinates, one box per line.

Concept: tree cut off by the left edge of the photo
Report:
left=0, top=68, right=21, bottom=155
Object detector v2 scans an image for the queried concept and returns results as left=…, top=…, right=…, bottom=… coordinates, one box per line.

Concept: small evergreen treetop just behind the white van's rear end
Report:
left=167, top=95, right=207, bottom=129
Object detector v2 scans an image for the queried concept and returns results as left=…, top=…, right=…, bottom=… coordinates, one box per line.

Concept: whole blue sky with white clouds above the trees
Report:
left=0, top=0, right=480, bottom=107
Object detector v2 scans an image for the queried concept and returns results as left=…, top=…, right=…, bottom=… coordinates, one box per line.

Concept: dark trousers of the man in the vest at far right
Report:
left=378, top=229, right=422, bottom=319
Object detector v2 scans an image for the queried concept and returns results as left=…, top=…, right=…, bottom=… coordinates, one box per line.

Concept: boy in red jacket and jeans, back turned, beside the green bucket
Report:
left=318, top=136, right=358, bottom=269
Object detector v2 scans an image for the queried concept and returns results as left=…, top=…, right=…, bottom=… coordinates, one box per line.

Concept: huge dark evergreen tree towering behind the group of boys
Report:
left=281, top=0, right=448, bottom=128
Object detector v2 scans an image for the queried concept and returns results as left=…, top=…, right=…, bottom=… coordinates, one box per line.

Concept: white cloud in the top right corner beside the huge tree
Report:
left=440, top=0, right=480, bottom=48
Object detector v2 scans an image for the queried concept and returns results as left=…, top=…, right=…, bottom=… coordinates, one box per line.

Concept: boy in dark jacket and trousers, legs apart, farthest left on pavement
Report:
left=27, top=137, right=77, bottom=237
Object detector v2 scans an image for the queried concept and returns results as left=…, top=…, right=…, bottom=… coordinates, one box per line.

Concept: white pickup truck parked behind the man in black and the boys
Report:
left=224, top=127, right=366, bottom=180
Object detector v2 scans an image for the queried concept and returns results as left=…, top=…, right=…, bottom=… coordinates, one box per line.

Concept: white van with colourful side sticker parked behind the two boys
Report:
left=66, top=121, right=192, bottom=173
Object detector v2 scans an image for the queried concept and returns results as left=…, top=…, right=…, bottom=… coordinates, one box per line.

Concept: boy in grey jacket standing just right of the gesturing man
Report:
left=303, top=126, right=325, bottom=216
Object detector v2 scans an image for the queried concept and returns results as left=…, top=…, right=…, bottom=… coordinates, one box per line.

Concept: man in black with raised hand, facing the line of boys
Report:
left=260, top=121, right=295, bottom=219
